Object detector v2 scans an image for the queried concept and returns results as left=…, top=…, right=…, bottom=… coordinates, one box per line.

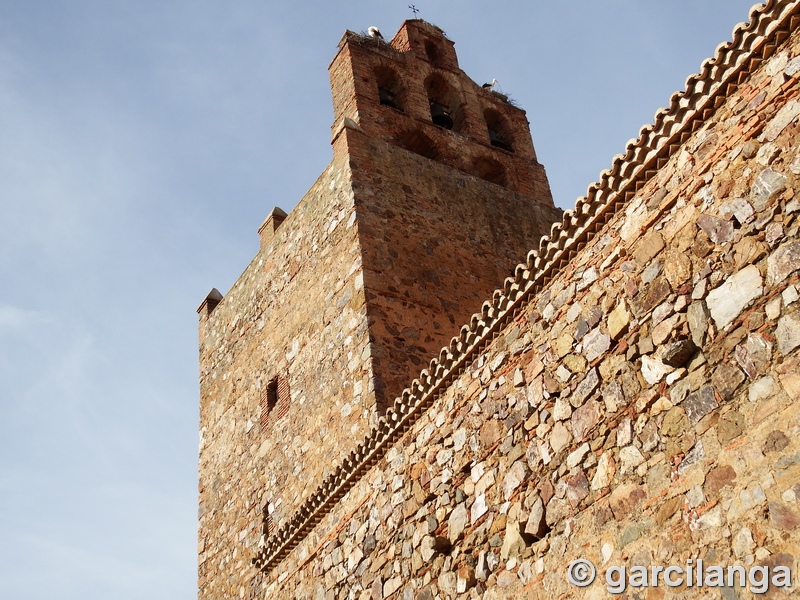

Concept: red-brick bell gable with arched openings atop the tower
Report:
left=329, top=19, right=553, bottom=197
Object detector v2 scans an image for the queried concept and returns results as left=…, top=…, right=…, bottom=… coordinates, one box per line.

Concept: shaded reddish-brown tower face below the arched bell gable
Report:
left=340, top=126, right=560, bottom=413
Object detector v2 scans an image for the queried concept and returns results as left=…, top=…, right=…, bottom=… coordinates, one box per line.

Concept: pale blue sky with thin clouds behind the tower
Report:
left=0, top=0, right=764, bottom=600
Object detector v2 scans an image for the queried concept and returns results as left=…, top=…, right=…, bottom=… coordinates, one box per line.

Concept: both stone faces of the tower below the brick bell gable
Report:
left=199, top=120, right=560, bottom=598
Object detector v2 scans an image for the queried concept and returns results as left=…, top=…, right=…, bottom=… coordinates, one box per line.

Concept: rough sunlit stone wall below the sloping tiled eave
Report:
left=253, top=21, right=800, bottom=600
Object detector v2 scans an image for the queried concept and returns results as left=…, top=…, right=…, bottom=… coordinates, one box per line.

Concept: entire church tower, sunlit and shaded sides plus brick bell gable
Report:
left=198, top=19, right=560, bottom=599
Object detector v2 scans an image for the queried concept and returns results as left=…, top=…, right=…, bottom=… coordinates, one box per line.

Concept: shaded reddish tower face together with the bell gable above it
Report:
left=329, top=19, right=560, bottom=408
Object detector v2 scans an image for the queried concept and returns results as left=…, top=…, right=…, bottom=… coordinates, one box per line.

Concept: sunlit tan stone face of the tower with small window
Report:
left=199, top=154, right=374, bottom=599
